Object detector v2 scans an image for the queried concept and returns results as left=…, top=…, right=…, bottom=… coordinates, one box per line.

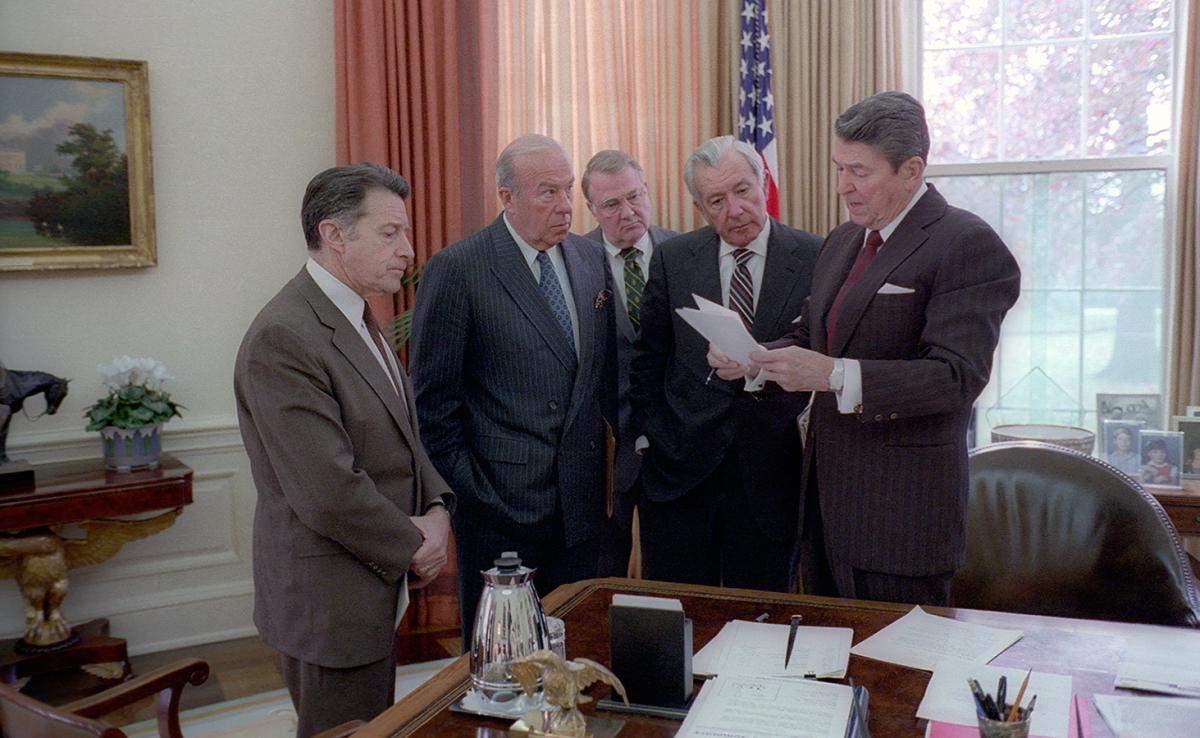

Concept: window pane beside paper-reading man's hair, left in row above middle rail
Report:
left=924, top=49, right=1000, bottom=163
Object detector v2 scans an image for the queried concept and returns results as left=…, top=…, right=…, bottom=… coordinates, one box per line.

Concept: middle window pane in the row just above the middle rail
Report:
left=1002, top=44, right=1082, bottom=160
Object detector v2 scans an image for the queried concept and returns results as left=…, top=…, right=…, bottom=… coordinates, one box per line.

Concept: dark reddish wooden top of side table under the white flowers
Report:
left=0, top=455, right=192, bottom=530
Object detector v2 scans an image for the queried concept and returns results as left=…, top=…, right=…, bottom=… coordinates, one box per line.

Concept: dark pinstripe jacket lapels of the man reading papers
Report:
left=822, top=185, right=946, bottom=356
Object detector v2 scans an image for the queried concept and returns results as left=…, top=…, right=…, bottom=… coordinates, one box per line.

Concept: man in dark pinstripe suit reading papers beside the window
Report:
left=709, top=92, right=1020, bottom=605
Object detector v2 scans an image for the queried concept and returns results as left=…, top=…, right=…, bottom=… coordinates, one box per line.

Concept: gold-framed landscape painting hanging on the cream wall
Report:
left=0, top=52, right=156, bottom=271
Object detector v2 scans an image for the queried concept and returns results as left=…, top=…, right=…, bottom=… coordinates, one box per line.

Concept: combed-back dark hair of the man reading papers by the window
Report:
left=833, top=91, right=929, bottom=172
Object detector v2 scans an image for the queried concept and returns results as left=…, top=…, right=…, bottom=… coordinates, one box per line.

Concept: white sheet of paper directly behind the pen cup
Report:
left=917, top=660, right=1070, bottom=738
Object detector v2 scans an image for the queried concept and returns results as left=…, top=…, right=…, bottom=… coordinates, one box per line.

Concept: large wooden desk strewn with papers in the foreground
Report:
left=354, top=578, right=1200, bottom=738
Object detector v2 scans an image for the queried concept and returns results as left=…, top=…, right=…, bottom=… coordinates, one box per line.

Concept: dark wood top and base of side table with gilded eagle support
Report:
left=0, top=456, right=192, bottom=684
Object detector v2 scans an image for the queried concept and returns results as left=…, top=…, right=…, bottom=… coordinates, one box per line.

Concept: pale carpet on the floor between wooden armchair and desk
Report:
left=124, top=659, right=454, bottom=738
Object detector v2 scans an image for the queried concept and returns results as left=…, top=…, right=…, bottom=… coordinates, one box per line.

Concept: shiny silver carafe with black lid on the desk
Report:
left=470, top=551, right=550, bottom=704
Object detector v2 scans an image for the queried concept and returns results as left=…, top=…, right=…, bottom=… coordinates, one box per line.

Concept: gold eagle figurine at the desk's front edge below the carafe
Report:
left=512, top=649, right=629, bottom=738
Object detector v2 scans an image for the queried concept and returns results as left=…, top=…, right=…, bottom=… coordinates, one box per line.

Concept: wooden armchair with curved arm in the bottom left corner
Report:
left=0, top=659, right=209, bottom=738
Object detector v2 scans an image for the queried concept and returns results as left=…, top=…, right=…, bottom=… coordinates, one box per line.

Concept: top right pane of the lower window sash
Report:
left=1084, top=170, right=1166, bottom=289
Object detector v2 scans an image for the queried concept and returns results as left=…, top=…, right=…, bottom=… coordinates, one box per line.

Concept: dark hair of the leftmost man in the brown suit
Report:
left=300, top=162, right=413, bottom=251
